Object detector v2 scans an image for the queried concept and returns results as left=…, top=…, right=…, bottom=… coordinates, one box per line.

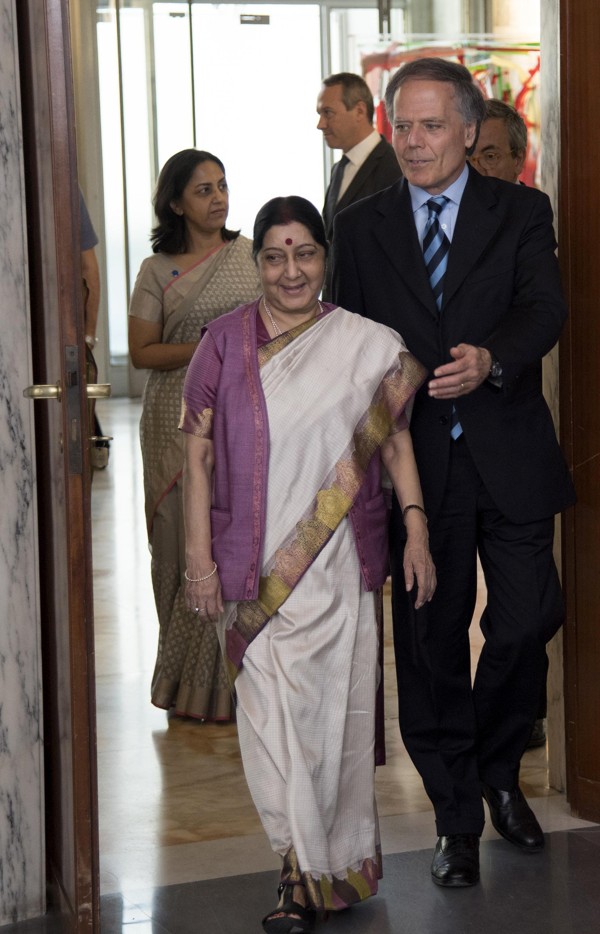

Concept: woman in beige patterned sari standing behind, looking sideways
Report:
left=129, top=149, right=258, bottom=721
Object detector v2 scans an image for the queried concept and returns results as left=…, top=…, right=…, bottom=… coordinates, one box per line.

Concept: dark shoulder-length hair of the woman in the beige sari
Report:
left=150, top=149, right=240, bottom=254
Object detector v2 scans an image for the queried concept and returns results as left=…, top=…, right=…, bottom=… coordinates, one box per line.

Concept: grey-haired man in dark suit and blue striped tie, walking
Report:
left=332, top=59, right=574, bottom=886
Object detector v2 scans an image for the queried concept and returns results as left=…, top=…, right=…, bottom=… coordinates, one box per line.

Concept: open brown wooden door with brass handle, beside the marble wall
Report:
left=16, top=0, right=99, bottom=934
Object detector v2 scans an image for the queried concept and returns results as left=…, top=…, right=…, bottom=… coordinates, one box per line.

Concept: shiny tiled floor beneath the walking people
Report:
left=7, top=400, right=600, bottom=934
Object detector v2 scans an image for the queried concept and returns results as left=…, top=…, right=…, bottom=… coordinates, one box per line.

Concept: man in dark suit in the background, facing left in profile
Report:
left=317, top=72, right=401, bottom=240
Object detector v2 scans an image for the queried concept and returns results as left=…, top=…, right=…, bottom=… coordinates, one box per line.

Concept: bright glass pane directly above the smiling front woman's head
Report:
left=192, top=3, right=324, bottom=236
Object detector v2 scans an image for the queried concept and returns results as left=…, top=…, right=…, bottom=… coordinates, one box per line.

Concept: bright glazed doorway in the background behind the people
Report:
left=95, top=0, right=404, bottom=396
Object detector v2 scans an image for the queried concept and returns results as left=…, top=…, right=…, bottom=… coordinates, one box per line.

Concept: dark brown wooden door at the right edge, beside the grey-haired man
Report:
left=558, top=0, right=600, bottom=821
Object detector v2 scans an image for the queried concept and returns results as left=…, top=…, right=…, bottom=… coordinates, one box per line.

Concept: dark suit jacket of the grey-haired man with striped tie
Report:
left=332, top=169, right=574, bottom=523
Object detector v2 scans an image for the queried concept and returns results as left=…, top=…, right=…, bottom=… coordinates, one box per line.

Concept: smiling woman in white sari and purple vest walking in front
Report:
left=180, top=197, right=435, bottom=934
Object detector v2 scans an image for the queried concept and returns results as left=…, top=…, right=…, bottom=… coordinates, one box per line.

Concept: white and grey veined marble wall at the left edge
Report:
left=0, top=0, right=45, bottom=924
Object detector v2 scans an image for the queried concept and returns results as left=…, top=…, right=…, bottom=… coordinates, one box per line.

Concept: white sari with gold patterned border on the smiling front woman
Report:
left=220, top=309, right=423, bottom=910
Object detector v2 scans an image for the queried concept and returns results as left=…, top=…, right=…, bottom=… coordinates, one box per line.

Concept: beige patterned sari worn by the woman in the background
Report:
left=130, top=237, right=259, bottom=720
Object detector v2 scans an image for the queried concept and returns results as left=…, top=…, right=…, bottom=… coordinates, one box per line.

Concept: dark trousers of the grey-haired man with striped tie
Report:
left=391, top=437, right=563, bottom=835
